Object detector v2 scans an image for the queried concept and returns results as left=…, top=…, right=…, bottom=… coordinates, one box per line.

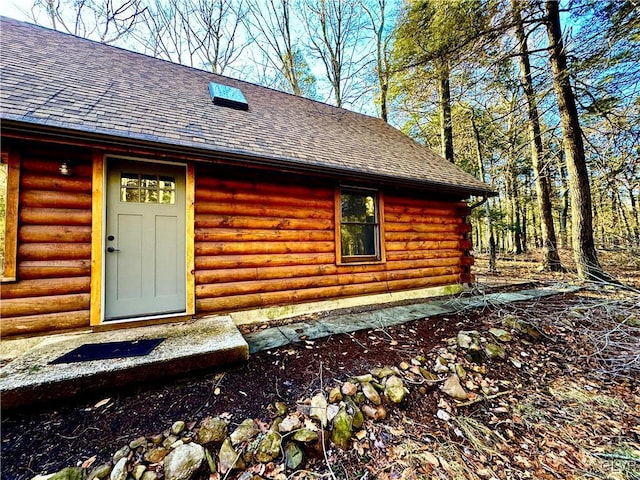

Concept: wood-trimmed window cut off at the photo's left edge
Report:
left=0, top=151, right=20, bottom=281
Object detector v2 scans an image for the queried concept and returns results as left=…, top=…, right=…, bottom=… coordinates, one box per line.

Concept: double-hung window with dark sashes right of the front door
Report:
left=336, top=187, right=383, bottom=263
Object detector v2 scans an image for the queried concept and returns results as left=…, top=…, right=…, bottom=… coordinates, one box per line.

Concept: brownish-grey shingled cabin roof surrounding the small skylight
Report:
left=0, top=18, right=492, bottom=196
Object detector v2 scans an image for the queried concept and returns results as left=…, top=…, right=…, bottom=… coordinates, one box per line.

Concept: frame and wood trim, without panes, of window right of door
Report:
left=335, top=186, right=386, bottom=265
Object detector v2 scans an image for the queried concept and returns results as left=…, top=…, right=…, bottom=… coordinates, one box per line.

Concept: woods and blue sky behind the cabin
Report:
left=24, top=0, right=640, bottom=281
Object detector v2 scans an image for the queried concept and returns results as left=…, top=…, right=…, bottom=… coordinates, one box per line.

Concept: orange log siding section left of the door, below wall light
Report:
left=0, top=149, right=91, bottom=336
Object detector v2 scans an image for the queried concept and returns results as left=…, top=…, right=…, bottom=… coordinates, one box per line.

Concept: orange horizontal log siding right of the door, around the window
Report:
left=195, top=171, right=467, bottom=314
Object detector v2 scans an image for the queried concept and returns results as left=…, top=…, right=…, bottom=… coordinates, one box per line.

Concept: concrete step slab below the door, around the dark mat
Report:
left=0, top=316, right=249, bottom=410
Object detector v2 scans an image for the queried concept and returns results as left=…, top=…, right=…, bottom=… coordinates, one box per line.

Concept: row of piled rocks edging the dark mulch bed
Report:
left=34, top=318, right=529, bottom=480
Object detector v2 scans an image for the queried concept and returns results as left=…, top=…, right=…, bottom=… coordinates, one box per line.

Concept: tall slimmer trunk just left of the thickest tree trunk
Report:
left=511, top=0, right=564, bottom=272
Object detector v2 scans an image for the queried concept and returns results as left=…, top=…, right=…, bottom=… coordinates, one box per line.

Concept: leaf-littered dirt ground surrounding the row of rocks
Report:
left=1, top=252, right=640, bottom=480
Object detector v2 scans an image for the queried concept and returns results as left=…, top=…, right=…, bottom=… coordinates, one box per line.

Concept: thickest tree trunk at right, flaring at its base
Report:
left=545, top=0, right=614, bottom=282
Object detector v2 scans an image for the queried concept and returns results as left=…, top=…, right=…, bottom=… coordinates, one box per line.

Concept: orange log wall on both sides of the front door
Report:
left=0, top=140, right=473, bottom=336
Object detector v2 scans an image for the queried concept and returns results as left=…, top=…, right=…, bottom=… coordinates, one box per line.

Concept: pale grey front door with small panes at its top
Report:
left=105, top=159, right=186, bottom=320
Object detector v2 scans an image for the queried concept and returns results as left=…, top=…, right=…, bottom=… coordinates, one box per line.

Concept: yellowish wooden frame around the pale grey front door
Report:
left=90, top=151, right=196, bottom=327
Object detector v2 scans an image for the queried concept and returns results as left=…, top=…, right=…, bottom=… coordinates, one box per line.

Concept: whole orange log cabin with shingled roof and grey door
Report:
left=0, top=18, right=493, bottom=337
